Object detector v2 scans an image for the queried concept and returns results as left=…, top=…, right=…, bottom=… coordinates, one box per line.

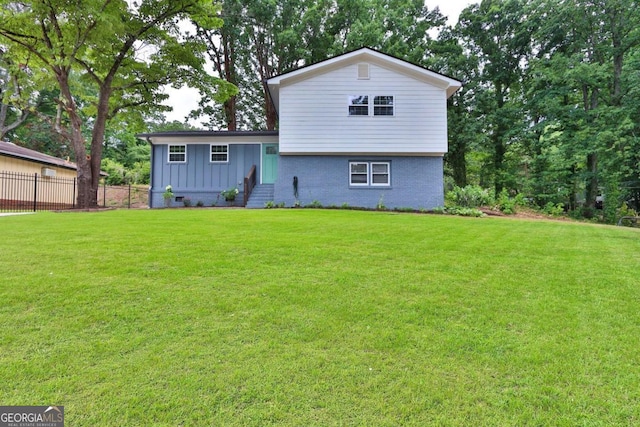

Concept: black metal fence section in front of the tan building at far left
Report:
left=0, top=171, right=76, bottom=212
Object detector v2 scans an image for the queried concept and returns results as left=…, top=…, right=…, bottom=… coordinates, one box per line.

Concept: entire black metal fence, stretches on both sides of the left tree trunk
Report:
left=0, top=171, right=149, bottom=212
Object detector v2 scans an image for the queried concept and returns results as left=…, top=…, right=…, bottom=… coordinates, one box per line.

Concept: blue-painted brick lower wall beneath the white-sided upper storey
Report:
left=274, top=156, right=444, bottom=209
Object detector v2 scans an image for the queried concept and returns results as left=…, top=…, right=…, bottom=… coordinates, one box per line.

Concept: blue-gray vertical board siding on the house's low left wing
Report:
left=149, top=144, right=260, bottom=207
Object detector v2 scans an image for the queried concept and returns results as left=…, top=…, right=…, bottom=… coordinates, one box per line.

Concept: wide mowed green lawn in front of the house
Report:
left=0, top=209, right=640, bottom=426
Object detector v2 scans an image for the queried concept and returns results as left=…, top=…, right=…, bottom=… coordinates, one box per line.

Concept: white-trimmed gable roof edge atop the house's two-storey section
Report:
left=267, top=47, right=462, bottom=111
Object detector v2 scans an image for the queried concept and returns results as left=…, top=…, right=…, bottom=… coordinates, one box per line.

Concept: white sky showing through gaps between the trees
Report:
left=165, top=0, right=480, bottom=125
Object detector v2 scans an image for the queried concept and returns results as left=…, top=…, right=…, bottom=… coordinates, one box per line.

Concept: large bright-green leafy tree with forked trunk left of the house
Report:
left=0, top=0, right=232, bottom=208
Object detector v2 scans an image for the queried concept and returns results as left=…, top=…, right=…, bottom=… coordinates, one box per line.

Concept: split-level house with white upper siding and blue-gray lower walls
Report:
left=139, top=48, right=461, bottom=209
